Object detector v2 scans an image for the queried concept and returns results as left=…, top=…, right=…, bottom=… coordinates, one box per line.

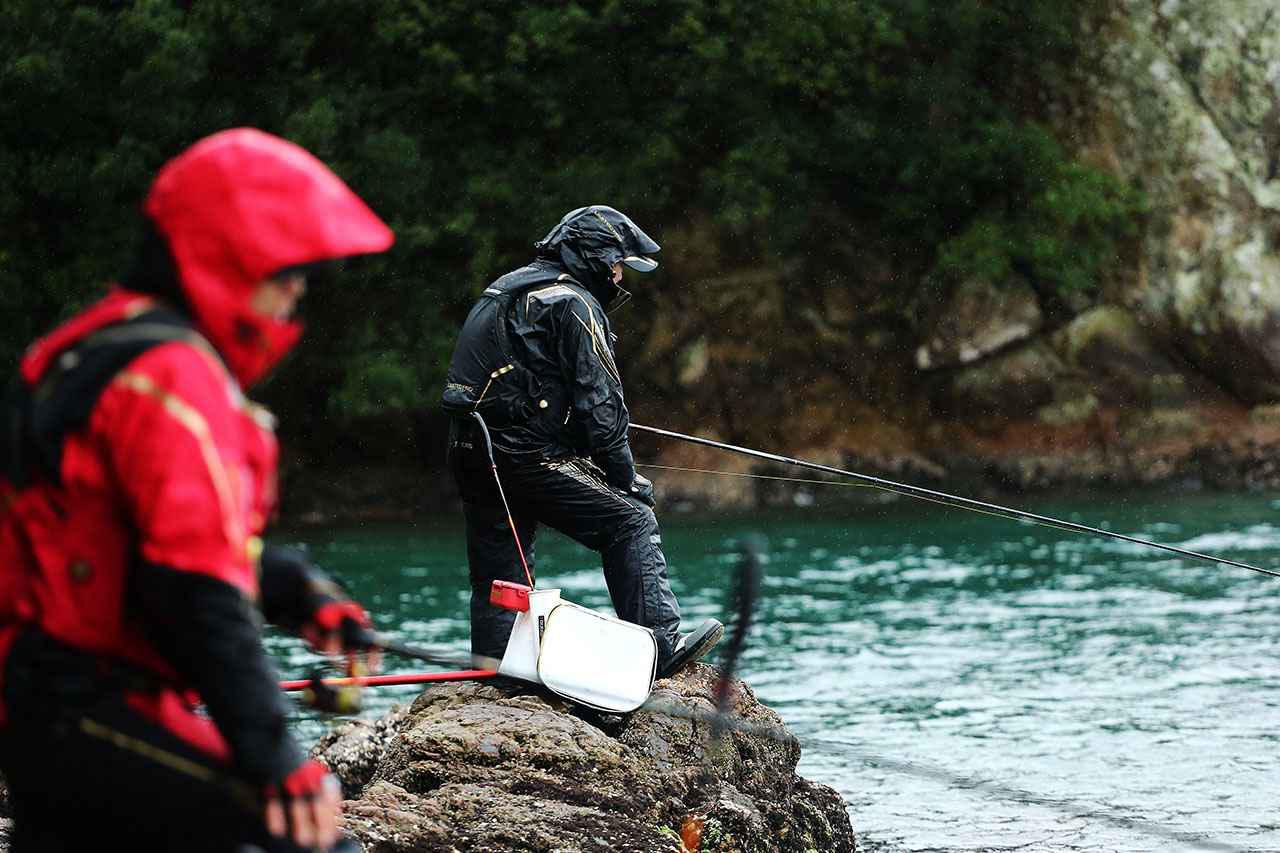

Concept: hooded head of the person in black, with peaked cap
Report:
left=534, top=205, right=660, bottom=307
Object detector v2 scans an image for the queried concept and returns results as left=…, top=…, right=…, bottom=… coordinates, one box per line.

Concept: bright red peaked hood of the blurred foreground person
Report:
left=143, top=128, right=394, bottom=387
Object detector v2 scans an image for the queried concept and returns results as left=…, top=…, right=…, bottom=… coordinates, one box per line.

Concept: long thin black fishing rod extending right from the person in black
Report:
left=631, top=424, right=1280, bottom=578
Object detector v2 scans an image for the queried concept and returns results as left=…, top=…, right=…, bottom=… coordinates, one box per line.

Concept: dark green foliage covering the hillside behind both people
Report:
left=0, top=0, right=1138, bottom=432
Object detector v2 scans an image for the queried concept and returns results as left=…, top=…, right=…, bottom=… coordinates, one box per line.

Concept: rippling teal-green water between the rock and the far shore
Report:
left=270, top=494, right=1280, bottom=850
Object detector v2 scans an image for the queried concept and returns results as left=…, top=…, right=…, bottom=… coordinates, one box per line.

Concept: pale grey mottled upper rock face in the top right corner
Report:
left=1082, top=0, right=1280, bottom=403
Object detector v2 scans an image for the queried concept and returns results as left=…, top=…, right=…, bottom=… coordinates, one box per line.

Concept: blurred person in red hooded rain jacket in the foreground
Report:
left=0, top=128, right=393, bottom=853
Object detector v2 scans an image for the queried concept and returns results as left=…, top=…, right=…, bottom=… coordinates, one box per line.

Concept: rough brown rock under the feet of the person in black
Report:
left=315, top=665, right=855, bottom=853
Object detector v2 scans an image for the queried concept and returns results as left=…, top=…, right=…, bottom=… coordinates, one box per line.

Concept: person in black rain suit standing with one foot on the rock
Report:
left=443, top=205, right=722, bottom=678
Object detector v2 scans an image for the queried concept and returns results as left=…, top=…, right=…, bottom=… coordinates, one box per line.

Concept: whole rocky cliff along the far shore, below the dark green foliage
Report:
left=270, top=0, right=1280, bottom=517
